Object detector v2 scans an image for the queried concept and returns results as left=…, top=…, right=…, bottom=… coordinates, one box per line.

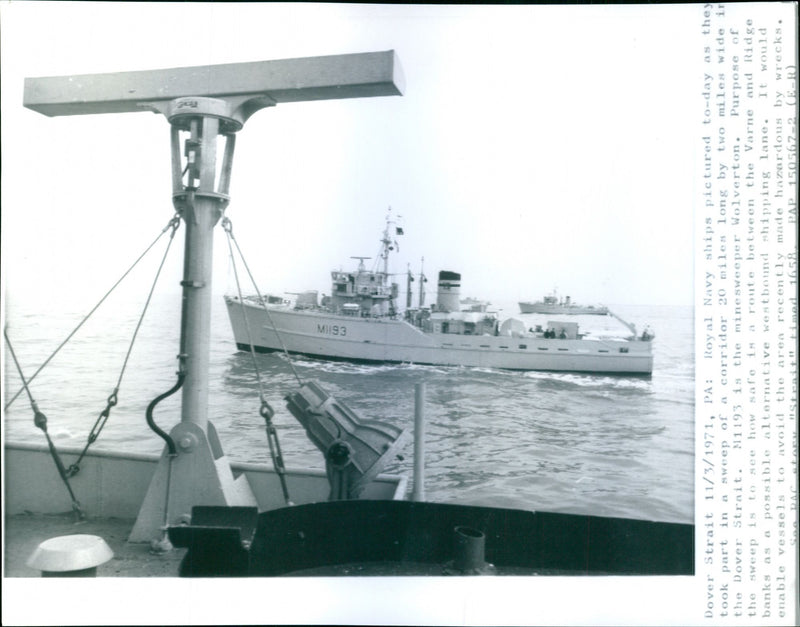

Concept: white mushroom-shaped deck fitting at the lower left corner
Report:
left=27, top=534, right=114, bottom=577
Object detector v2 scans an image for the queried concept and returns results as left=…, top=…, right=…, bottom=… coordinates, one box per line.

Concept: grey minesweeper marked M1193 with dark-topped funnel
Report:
left=225, top=218, right=653, bottom=375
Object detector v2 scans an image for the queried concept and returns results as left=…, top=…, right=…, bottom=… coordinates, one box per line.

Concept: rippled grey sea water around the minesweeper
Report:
left=4, top=295, right=694, bottom=523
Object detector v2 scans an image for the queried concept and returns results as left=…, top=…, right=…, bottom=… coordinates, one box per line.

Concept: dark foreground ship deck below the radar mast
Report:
left=4, top=444, right=694, bottom=577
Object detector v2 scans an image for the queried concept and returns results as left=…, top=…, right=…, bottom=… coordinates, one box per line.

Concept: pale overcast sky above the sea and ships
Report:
left=2, top=2, right=701, bottom=312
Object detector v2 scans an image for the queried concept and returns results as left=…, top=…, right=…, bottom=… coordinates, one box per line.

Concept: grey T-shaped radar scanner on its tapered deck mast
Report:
left=23, top=50, right=403, bottom=542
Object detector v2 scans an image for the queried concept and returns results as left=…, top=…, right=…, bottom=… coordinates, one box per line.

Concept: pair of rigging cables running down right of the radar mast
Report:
left=222, top=216, right=296, bottom=505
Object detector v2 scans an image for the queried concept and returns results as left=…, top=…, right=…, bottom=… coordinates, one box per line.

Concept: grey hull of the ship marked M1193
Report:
left=226, top=297, right=653, bottom=375
